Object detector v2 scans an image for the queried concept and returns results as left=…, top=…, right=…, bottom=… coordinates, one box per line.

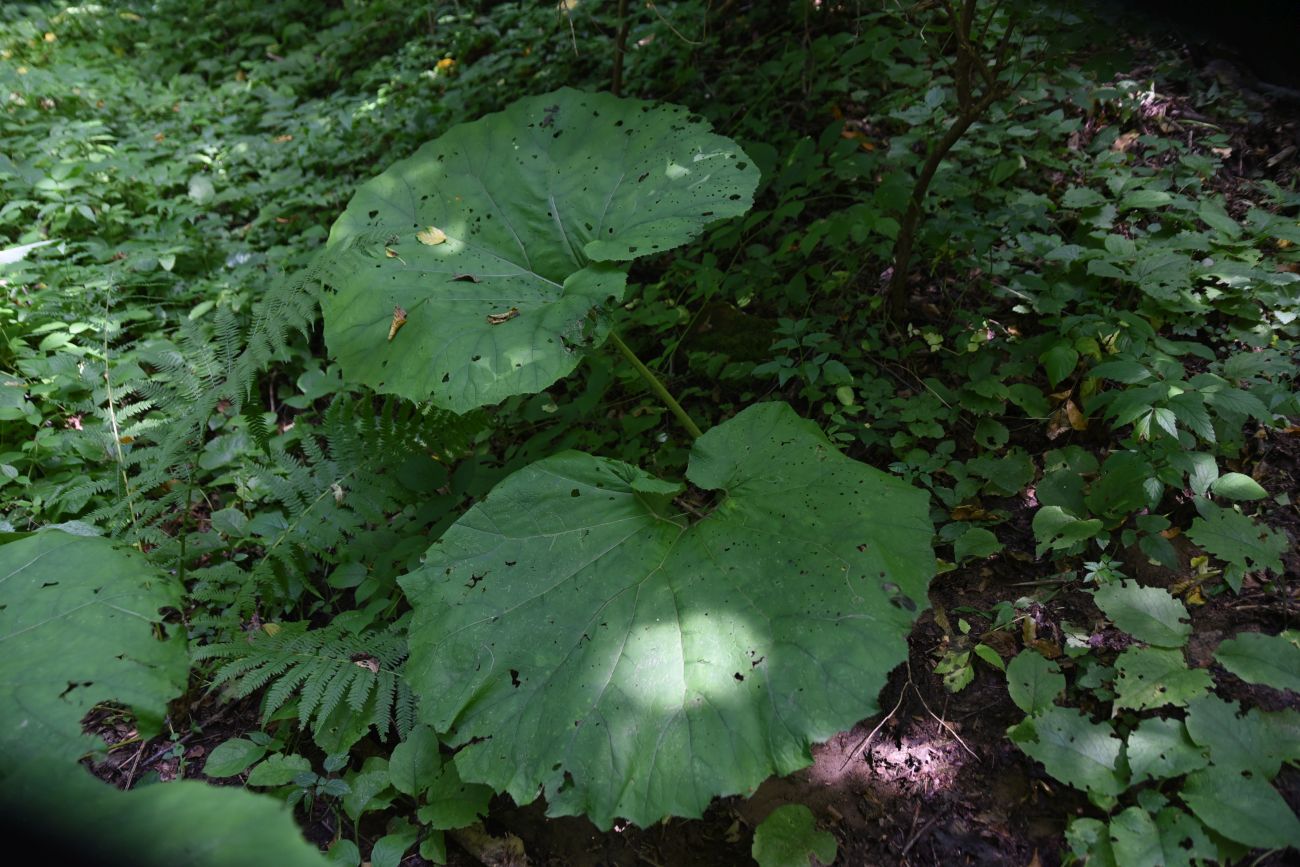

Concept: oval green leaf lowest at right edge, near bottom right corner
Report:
left=1180, top=766, right=1300, bottom=849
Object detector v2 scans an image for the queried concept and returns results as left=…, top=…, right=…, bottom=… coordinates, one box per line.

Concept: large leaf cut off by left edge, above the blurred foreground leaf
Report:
left=0, top=530, right=190, bottom=776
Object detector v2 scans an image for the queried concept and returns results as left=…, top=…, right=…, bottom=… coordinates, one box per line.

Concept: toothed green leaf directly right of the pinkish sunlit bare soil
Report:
left=1008, top=707, right=1125, bottom=797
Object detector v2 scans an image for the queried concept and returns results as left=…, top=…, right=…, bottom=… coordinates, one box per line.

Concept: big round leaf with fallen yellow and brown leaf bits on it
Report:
left=322, top=88, right=758, bottom=412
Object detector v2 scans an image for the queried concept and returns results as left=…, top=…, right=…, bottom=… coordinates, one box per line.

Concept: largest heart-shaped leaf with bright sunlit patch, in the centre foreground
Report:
left=402, top=403, right=935, bottom=827
